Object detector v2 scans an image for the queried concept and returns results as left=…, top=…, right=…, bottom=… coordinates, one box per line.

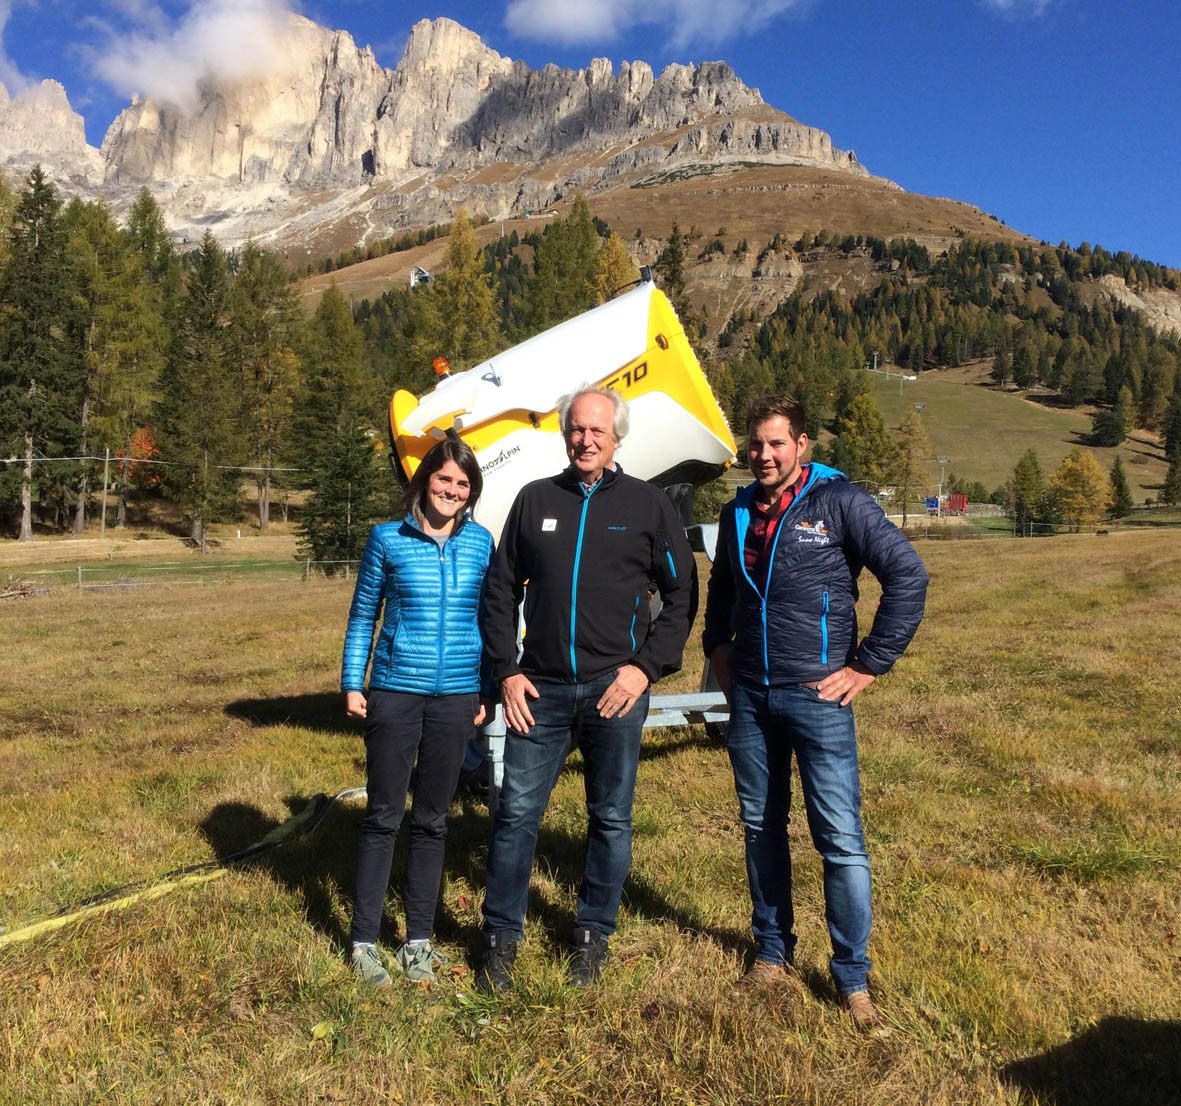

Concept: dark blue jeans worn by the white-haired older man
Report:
left=484, top=671, right=648, bottom=939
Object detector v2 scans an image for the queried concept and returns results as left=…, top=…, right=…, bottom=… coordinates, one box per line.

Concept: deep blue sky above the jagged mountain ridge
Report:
left=0, top=0, right=1181, bottom=268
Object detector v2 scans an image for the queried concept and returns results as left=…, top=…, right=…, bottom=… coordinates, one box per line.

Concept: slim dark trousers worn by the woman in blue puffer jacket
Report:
left=351, top=689, right=479, bottom=943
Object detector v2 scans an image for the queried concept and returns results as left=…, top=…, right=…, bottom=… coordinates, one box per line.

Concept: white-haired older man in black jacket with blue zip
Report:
left=477, top=388, right=697, bottom=990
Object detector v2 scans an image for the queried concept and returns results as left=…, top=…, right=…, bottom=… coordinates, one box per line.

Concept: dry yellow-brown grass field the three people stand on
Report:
left=0, top=532, right=1181, bottom=1106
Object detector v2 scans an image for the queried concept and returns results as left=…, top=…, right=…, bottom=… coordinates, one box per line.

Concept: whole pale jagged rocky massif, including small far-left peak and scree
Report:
left=0, top=15, right=868, bottom=249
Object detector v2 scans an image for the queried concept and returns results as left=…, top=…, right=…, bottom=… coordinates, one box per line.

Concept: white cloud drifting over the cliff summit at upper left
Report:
left=87, top=0, right=297, bottom=111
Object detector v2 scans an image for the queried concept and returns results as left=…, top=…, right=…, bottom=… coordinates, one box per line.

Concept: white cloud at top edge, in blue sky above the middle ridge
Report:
left=504, top=0, right=808, bottom=48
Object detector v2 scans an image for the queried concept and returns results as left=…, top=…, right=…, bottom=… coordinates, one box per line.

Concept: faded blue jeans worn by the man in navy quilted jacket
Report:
left=726, top=684, right=873, bottom=995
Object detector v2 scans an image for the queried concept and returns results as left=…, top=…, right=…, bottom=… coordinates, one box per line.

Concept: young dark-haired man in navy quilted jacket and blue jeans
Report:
left=702, top=396, right=927, bottom=1030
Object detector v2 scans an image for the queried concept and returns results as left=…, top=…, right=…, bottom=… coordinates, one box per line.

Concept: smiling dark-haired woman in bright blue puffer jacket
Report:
left=340, top=440, right=492, bottom=987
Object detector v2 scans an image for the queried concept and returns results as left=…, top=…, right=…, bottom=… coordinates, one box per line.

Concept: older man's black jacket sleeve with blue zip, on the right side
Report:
left=635, top=492, right=697, bottom=683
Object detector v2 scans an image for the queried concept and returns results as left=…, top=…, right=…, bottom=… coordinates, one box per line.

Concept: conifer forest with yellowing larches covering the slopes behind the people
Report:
left=0, top=169, right=1181, bottom=559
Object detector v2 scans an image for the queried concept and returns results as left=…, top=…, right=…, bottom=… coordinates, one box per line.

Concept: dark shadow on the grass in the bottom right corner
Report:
left=1000, top=1017, right=1181, bottom=1106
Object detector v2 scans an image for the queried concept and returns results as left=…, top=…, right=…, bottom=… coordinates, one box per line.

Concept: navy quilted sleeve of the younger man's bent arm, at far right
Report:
left=844, top=489, right=927, bottom=676
